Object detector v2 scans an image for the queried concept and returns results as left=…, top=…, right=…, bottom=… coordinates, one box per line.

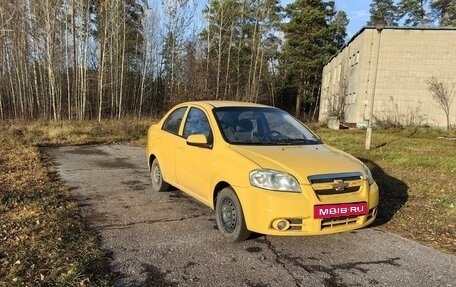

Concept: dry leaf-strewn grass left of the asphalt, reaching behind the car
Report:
left=0, top=121, right=153, bottom=286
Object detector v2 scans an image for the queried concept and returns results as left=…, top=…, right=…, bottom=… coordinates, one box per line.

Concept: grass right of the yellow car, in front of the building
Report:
left=316, top=127, right=456, bottom=254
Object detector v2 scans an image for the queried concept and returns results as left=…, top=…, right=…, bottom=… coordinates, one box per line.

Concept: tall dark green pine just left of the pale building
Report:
left=281, top=0, right=348, bottom=117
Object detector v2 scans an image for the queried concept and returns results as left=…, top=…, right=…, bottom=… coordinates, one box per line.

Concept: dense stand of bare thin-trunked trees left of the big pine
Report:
left=0, top=0, right=280, bottom=120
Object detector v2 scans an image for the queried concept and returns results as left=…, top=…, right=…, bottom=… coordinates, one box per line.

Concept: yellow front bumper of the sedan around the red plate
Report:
left=236, top=181, right=379, bottom=236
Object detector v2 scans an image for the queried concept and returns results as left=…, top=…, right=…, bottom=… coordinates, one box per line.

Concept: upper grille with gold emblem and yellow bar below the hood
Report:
left=308, top=172, right=364, bottom=195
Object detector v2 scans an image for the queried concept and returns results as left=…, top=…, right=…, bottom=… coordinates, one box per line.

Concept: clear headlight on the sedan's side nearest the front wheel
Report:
left=250, top=169, right=301, bottom=192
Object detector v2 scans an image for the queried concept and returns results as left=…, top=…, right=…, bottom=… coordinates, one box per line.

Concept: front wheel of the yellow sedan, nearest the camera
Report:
left=215, top=187, right=251, bottom=242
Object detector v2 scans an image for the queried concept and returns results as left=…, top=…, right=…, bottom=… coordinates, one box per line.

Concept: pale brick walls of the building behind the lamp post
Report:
left=319, top=28, right=456, bottom=127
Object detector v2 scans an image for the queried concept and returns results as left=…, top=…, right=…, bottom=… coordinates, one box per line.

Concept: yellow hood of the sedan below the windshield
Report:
left=230, top=145, right=364, bottom=184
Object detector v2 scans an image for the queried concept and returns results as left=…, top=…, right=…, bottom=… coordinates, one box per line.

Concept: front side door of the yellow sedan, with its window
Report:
left=176, top=107, right=214, bottom=204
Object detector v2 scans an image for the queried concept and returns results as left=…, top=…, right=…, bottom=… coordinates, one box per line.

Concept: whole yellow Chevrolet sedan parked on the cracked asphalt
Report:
left=147, top=101, right=379, bottom=241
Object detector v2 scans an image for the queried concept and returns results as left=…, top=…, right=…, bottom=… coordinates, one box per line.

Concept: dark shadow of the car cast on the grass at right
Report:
left=359, top=158, right=409, bottom=227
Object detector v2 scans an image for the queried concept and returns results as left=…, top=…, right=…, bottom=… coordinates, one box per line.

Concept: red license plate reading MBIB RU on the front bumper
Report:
left=314, top=202, right=368, bottom=219
